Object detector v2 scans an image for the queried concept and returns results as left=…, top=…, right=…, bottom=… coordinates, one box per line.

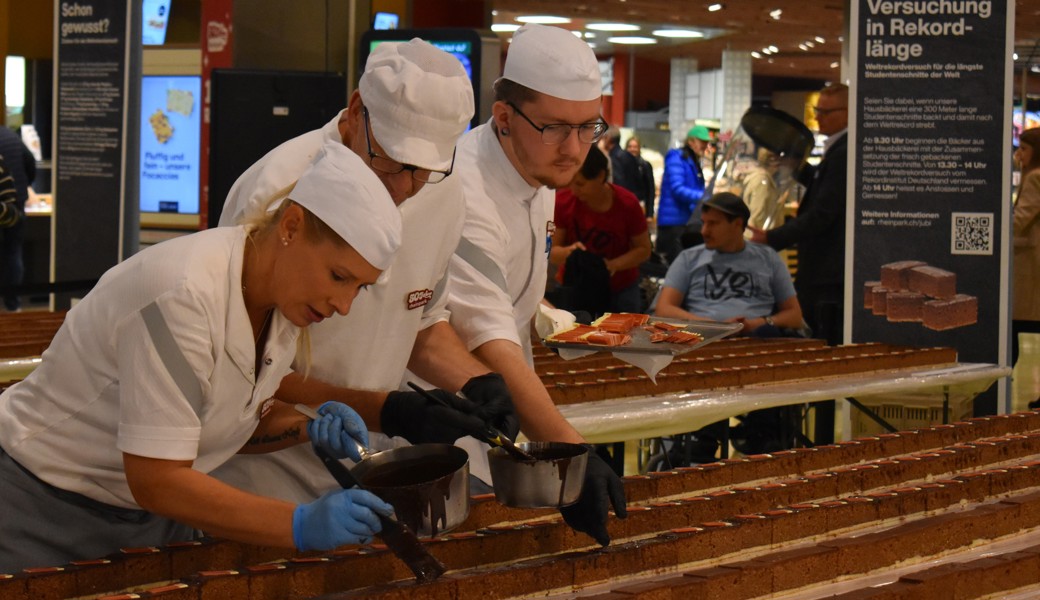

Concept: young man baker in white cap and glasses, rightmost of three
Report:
left=448, top=25, right=626, bottom=546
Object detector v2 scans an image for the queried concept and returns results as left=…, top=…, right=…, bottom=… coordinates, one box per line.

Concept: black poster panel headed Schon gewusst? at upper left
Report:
left=52, top=0, right=129, bottom=308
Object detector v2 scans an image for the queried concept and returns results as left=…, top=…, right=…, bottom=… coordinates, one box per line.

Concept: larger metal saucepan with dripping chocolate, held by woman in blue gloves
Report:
left=296, top=405, right=469, bottom=537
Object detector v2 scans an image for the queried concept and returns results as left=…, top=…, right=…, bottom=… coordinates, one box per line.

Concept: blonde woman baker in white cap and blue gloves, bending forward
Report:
left=0, top=144, right=400, bottom=573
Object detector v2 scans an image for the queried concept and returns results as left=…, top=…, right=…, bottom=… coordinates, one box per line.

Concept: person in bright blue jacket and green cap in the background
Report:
left=654, top=125, right=711, bottom=264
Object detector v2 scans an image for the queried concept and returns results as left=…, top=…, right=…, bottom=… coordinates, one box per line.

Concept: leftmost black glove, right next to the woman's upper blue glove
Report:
left=380, top=390, right=485, bottom=444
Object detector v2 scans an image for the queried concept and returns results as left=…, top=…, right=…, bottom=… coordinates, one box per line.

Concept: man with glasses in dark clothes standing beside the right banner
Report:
left=750, top=83, right=849, bottom=345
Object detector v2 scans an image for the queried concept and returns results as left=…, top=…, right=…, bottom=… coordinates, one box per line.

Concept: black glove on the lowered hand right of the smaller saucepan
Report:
left=560, top=445, right=628, bottom=546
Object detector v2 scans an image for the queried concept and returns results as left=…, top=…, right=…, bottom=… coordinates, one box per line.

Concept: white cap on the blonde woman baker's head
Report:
left=289, top=141, right=401, bottom=270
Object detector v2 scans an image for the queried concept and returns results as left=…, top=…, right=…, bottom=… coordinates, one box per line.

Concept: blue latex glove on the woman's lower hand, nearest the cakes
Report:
left=292, top=490, right=393, bottom=550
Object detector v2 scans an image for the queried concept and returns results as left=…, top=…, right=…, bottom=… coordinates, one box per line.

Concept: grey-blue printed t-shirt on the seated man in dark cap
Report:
left=665, top=241, right=795, bottom=321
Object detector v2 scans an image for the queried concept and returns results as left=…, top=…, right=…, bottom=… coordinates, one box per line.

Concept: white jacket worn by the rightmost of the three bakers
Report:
left=448, top=122, right=555, bottom=361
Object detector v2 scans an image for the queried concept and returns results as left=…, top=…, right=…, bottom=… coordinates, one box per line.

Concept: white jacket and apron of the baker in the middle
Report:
left=213, top=111, right=465, bottom=502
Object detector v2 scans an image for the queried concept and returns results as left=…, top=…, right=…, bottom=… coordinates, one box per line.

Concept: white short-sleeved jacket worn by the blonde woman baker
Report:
left=0, top=227, right=300, bottom=508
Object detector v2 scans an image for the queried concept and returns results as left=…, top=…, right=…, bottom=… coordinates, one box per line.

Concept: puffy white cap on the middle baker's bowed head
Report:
left=358, top=37, right=473, bottom=171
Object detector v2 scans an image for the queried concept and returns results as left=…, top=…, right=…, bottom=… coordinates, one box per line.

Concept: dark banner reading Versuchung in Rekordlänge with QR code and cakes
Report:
left=846, top=0, right=1014, bottom=408
